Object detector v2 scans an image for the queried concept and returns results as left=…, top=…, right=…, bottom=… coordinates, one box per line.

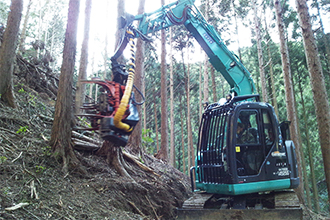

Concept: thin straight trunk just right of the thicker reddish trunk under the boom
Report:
left=170, top=27, right=175, bottom=167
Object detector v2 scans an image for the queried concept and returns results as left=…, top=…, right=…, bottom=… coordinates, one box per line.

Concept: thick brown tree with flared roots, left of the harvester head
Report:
left=50, top=0, right=80, bottom=173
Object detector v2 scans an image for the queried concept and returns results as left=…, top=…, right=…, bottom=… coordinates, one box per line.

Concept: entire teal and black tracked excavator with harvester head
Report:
left=83, top=0, right=302, bottom=219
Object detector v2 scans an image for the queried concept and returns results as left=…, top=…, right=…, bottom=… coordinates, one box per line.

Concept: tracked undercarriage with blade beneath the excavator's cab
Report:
left=178, top=190, right=302, bottom=220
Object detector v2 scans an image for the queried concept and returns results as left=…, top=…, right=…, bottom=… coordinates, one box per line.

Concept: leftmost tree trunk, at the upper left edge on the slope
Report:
left=0, top=0, right=23, bottom=108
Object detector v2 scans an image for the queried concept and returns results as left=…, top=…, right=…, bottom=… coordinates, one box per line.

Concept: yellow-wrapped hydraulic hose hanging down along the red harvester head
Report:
left=113, top=30, right=135, bottom=132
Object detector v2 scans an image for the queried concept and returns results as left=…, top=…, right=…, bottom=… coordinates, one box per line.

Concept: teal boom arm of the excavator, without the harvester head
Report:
left=130, top=0, right=256, bottom=95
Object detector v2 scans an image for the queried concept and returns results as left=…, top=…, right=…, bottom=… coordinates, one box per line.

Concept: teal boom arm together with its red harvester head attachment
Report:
left=80, top=0, right=256, bottom=146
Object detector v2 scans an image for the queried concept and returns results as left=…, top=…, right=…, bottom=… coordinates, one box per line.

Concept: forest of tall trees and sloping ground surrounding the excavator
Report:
left=0, top=0, right=330, bottom=219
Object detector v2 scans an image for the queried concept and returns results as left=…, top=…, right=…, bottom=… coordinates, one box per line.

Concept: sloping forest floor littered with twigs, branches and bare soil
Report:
left=0, top=69, right=323, bottom=220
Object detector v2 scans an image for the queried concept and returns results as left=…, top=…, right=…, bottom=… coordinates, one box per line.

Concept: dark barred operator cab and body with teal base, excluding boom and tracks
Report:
left=195, top=95, right=299, bottom=195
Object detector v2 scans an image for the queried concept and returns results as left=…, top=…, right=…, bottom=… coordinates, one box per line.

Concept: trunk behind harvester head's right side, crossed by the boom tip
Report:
left=129, top=0, right=145, bottom=155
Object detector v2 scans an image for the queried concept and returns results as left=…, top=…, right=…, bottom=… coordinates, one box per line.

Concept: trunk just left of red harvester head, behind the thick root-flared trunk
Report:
left=75, top=0, right=92, bottom=114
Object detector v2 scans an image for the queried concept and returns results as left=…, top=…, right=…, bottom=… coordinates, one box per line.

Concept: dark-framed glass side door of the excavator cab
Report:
left=234, top=104, right=277, bottom=183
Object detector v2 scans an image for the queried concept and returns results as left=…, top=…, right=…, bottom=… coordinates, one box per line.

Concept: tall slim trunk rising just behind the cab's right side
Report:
left=274, top=0, right=305, bottom=204
